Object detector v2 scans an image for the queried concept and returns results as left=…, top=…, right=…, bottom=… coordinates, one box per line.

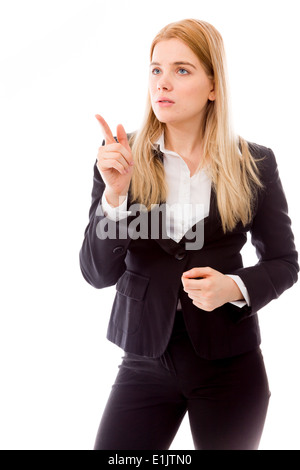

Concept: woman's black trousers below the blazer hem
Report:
left=94, top=311, right=270, bottom=450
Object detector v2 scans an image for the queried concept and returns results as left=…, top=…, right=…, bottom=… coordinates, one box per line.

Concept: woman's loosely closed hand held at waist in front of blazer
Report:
left=181, top=267, right=244, bottom=312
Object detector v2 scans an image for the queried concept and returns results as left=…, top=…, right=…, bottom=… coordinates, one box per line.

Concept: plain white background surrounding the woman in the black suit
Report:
left=0, top=0, right=300, bottom=450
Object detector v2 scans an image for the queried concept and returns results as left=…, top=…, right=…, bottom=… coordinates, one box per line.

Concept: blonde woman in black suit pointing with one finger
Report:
left=80, top=19, right=299, bottom=450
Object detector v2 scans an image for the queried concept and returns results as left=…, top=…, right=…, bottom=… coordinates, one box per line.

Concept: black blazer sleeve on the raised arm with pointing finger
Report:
left=79, top=163, right=130, bottom=289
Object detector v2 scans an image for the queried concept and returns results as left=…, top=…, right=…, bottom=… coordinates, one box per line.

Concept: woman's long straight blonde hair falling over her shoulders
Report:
left=130, top=19, right=261, bottom=232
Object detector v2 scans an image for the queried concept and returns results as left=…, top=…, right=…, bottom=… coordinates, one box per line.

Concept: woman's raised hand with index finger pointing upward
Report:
left=96, top=114, right=133, bottom=207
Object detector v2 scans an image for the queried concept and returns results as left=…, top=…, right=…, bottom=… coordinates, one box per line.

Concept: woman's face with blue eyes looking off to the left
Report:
left=149, top=39, right=215, bottom=129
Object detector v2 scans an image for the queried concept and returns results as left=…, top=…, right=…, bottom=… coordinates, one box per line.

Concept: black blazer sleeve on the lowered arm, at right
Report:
left=233, top=149, right=299, bottom=315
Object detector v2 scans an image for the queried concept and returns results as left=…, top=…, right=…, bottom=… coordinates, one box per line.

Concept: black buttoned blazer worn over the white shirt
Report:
left=80, top=144, right=299, bottom=359
